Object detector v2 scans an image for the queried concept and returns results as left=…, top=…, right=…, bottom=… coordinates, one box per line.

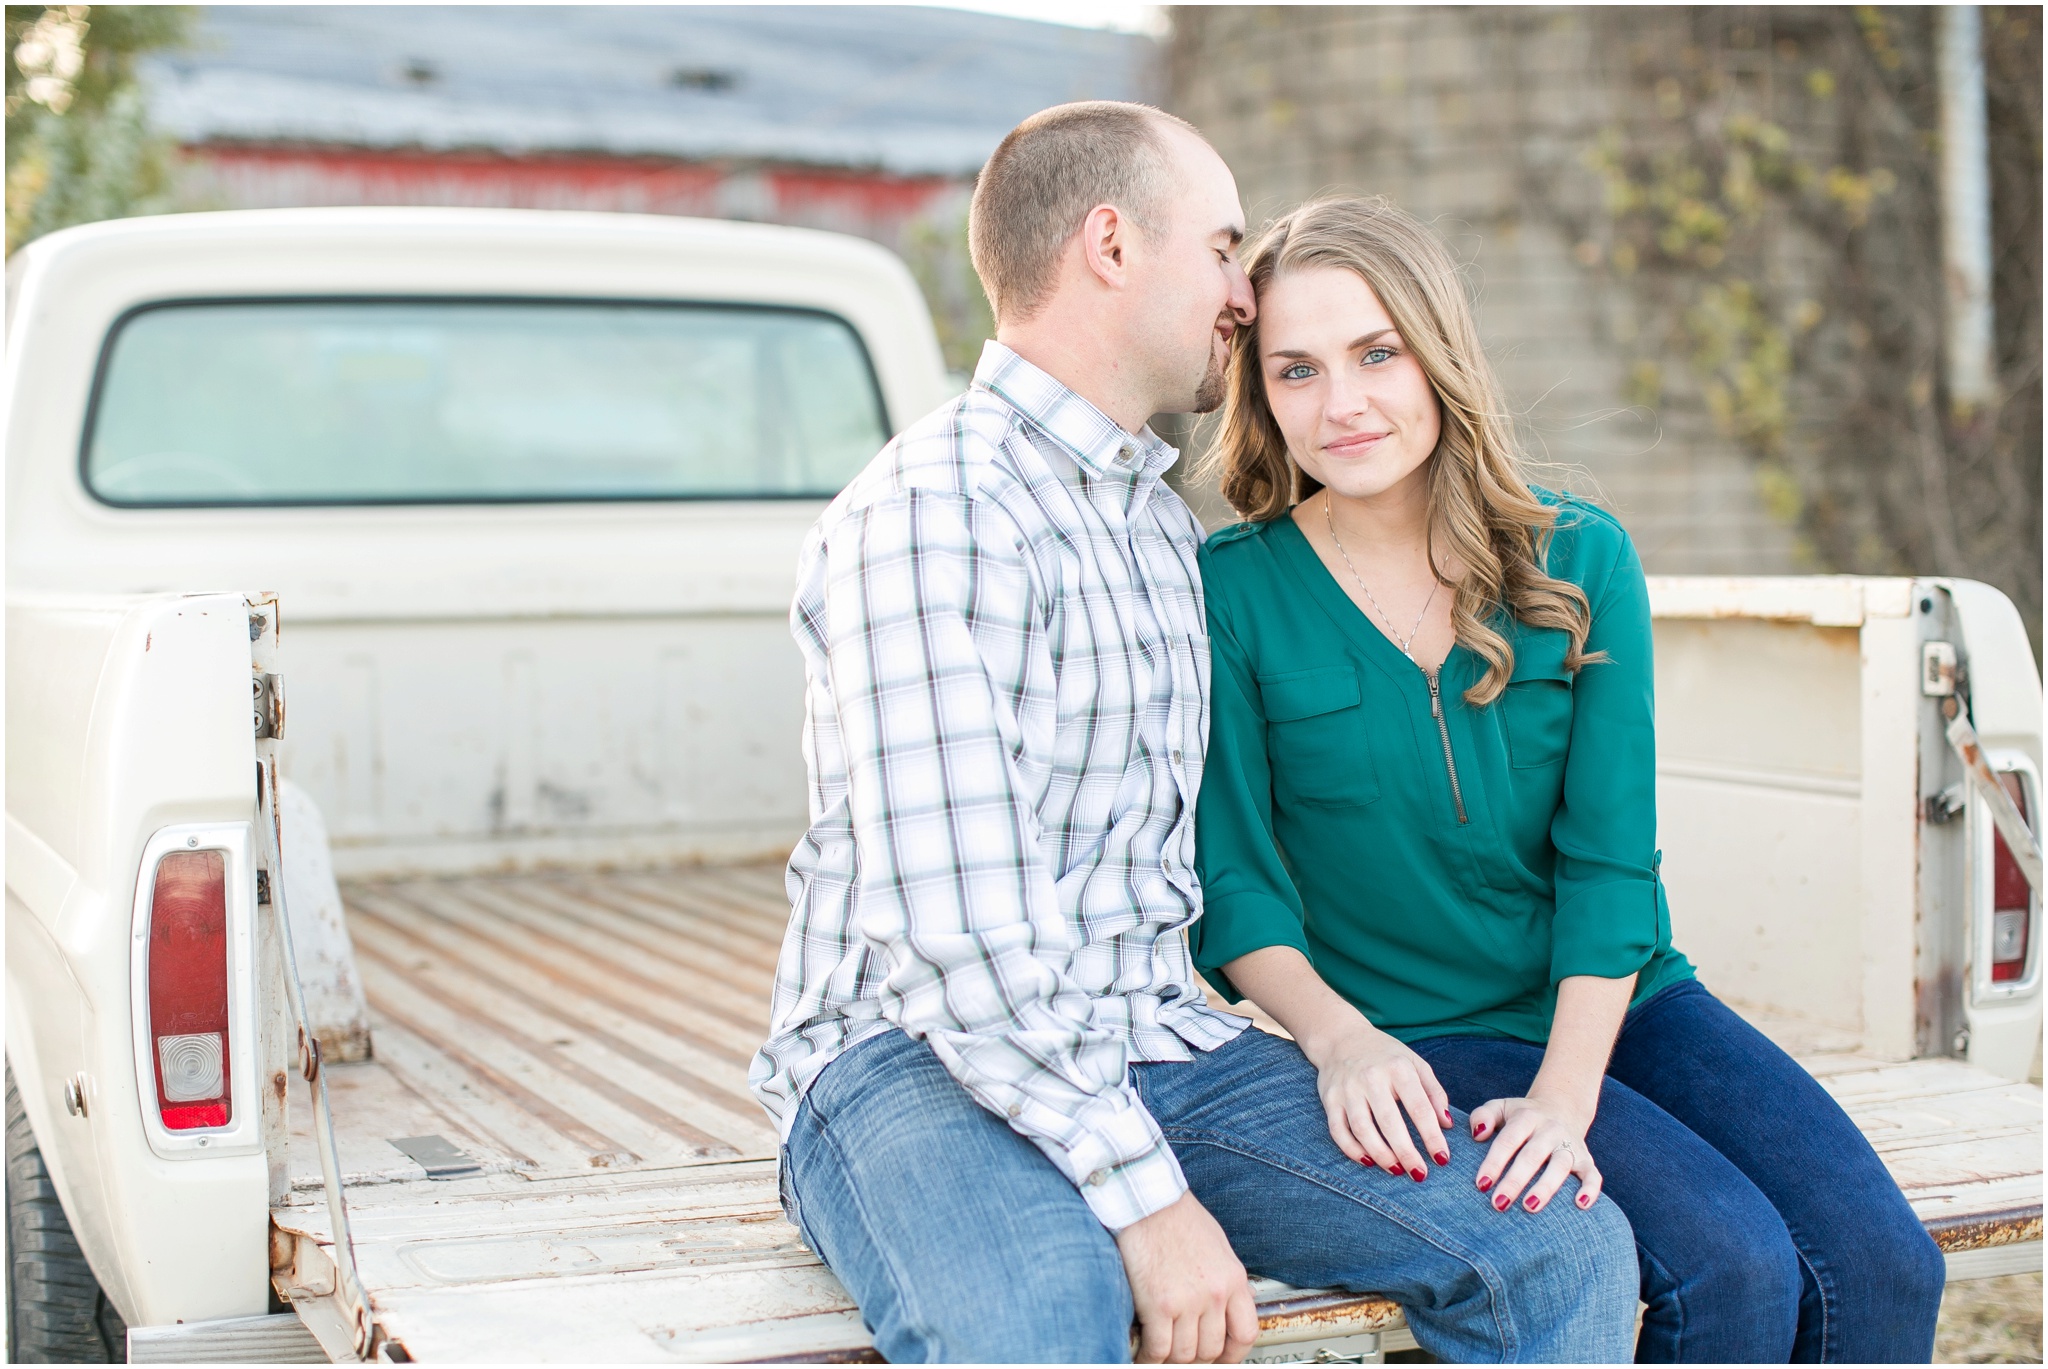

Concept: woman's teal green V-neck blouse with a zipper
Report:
left=1190, top=490, right=1692, bottom=1043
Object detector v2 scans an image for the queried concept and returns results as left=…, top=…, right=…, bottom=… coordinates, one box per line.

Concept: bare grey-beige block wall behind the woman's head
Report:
left=1165, top=6, right=1800, bottom=574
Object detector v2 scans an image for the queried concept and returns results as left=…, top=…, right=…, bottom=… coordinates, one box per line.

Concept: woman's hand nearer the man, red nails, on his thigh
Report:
left=1303, top=1010, right=1450, bottom=1183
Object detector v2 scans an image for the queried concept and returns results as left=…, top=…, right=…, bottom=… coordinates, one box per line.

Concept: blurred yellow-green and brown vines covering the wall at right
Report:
left=1546, top=6, right=2042, bottom=650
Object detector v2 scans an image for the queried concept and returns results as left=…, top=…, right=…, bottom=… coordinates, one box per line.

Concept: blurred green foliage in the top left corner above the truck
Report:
left=6, top=4, right=193, bottom=254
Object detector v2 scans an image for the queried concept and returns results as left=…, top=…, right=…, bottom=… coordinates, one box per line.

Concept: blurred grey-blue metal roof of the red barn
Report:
left=143, top=6, right=1157, bottom=174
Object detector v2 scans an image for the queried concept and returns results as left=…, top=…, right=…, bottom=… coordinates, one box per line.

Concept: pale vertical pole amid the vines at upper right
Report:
left=1935, top=4, right=1999, bottom=422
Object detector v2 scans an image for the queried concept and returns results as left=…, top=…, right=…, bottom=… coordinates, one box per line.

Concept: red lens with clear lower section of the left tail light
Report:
left=150, top=851, right=233, bottom=1131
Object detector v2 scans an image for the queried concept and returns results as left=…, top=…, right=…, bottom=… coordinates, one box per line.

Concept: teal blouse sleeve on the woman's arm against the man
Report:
left=1188, top=573, right=1315, bottom=1002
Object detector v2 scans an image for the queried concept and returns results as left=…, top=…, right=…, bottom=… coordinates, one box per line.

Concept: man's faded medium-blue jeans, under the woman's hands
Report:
left=782, top=1029, right=1636, bottom=1363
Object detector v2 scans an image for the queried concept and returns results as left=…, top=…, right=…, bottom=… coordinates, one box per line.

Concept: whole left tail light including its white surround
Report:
left=129, top=822, right=262, bottom=1158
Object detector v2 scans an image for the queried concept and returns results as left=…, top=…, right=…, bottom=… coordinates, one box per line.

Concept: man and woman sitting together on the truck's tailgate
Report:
left=752, top=102, right=1944, bottom=1363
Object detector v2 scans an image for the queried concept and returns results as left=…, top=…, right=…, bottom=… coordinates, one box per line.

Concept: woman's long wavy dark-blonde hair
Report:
left=1202, top=197, right=1599, bottom=707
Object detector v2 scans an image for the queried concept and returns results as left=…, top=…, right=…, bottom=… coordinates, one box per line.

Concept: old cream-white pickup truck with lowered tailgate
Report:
left=6, top=209, right=2042, bottom=1361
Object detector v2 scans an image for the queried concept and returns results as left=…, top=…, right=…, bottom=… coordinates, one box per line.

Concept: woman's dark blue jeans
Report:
left=1415, top=980, right=1948, bottom=1363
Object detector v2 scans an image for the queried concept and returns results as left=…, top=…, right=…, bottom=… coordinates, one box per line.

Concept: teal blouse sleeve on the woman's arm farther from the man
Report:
left=1550, top=512, right=1661, bottom=984
